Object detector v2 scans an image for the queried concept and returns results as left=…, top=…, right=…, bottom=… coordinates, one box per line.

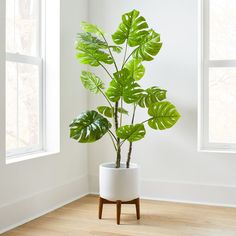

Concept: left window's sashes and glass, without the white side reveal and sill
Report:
left=5, top=0, right=44, bottom=157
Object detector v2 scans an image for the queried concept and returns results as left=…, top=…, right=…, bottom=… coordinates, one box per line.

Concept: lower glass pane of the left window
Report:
left=6, top=62, right=39, bottom=151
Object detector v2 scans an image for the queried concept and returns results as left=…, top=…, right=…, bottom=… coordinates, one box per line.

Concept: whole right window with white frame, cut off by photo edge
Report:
left=199, top=0, right=236, bottom=152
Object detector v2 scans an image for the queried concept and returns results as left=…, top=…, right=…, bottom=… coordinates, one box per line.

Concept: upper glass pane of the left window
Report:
left=6, top=0, right=39, bottom=56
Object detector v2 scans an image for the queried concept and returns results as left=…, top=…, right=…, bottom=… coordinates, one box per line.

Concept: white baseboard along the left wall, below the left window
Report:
left=0, top=176, right=88, bottom=234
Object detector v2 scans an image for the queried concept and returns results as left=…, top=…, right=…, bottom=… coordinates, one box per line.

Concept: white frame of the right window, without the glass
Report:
left=198, top=0, right=236, bottom=153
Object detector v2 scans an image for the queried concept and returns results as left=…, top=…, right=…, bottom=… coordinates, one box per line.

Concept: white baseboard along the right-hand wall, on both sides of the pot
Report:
left=89, top=175, right=236, bottom=207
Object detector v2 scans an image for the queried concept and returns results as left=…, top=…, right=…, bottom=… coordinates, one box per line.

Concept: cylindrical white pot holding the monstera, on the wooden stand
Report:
left=99, top=163, right=139, bottom=201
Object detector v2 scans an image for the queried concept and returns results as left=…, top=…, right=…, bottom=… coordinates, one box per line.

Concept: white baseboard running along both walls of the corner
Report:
left=0, top=175, right=236, bottom=234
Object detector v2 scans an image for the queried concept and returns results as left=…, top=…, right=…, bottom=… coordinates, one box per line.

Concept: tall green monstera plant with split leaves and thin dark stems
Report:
left=70, top=10, right=180, bottom=168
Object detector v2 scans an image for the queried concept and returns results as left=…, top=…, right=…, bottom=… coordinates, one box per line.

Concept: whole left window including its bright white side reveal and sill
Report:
left=3, top=0, right=60, bottom=164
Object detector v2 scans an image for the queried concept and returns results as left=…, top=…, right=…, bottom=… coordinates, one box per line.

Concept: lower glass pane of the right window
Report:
left=209, top=68, right=236, bottom=143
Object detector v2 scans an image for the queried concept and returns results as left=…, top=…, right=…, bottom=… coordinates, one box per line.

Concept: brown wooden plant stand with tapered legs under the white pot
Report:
left=98, top=197, right=140, bottom=225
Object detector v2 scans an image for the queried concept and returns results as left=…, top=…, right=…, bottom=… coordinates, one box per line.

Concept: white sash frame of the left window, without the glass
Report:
left=5, top=0, right=46, bottom=159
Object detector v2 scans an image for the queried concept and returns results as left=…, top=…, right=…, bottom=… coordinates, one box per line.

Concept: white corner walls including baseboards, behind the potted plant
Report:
left=0, top=0, right=236, bottom=232
